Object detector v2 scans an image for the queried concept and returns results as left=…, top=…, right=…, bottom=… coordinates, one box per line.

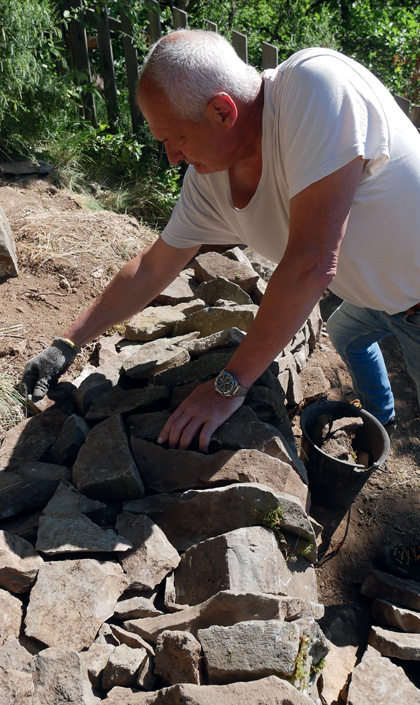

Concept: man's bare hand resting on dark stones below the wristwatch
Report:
left=158, top=380, right=245, bottom=453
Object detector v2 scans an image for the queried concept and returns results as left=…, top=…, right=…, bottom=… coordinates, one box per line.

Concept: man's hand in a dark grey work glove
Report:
left=19, top=338, right=81, bottom=401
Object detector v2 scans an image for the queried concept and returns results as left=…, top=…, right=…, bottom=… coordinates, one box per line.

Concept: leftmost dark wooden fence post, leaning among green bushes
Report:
left=60, top=0, right=97, bottom=125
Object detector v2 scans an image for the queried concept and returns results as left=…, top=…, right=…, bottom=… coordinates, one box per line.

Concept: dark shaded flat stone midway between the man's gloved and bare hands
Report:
left=85, top=385, right=169, bottom=425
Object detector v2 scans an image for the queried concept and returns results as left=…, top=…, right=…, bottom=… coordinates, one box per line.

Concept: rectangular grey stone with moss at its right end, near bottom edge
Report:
left=197, top=620, right=300, bottom=685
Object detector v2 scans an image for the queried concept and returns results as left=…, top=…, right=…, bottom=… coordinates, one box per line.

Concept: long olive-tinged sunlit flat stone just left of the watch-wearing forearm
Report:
left=174, top=304, right=258, bottom=338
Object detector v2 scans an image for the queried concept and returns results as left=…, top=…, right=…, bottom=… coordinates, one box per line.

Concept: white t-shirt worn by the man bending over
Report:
left=162, top=49, right=420, bottom=314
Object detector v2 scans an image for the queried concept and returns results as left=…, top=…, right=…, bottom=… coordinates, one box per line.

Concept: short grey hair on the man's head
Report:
left=139, top=29, right=261, bottom=122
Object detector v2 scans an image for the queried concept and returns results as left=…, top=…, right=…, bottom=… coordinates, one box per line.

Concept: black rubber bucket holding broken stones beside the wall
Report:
left=300, top=401, right=389, bottom=507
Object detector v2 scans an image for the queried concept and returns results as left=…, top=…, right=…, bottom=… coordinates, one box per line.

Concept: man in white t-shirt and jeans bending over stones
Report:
left=23, top=30, right=420, bottom=452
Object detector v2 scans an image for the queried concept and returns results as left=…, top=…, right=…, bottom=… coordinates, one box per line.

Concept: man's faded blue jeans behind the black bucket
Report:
left=327, top=301, right=420, bottom=423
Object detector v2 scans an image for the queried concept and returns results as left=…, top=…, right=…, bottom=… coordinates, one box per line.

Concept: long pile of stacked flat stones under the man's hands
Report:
left=0, top=248, right=328, bottom=705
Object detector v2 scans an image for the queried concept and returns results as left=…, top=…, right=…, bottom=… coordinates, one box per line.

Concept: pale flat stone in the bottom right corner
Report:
left=347, top=647, right=420, bottom=705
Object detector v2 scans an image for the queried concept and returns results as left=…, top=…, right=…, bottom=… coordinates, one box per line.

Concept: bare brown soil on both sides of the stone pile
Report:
left=0, top=177, right=420, bottom=640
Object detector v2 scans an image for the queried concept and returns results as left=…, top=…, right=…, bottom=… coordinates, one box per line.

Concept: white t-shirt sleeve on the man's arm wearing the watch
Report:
left=279, top=55, right=389, bottom=198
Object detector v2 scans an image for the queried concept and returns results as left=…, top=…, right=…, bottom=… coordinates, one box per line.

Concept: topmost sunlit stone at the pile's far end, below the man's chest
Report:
left=194, top=252, right=258, bottom=294
